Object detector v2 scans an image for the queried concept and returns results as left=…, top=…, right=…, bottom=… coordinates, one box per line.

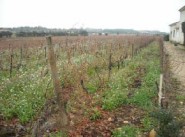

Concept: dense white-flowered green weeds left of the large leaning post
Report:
left=0, top=66, right=52, bottom=123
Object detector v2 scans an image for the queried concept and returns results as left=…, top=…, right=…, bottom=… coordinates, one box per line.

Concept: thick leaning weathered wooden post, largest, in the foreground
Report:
left=46, top=36, right=68, bottom=127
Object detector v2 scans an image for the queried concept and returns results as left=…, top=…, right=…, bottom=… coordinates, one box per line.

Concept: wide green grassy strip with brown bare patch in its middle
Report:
left=102, top=43, right=160, bottom=110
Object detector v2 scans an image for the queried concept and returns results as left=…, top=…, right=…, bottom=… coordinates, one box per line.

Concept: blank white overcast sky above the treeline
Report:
left=0, top=0, right=185, bottom=32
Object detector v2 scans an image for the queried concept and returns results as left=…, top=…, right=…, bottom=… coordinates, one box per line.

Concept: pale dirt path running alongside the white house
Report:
left=164, top=42, right=185, bottom=137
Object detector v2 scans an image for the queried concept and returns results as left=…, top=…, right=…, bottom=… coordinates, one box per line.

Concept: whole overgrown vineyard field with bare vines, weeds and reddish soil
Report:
left=0, top=35, right=168, bottom=137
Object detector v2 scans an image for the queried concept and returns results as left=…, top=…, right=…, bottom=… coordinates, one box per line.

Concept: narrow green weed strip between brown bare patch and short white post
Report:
left=128, top=45, right=160, bottom=110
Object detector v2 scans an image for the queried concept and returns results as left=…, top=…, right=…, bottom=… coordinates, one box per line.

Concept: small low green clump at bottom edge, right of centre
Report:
left=113, top=125, right=140, bottom=137
